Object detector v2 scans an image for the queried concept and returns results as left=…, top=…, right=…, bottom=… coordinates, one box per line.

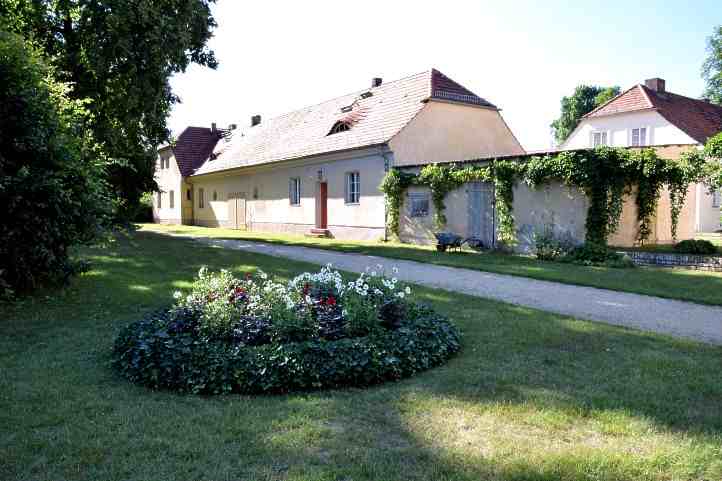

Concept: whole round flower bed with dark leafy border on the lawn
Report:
left=113, top=266, right=460, bottom=393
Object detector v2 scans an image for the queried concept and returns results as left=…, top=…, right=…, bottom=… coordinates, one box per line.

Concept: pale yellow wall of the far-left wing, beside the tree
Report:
left=153, top=148, right=185, bottom=224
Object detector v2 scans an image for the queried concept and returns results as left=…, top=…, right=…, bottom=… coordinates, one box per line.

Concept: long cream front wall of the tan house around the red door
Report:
left=190, top=149, right=385, bottom=240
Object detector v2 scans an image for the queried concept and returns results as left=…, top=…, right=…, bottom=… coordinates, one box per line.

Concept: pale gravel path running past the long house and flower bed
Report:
left=165, top=234, right=722, bottom=345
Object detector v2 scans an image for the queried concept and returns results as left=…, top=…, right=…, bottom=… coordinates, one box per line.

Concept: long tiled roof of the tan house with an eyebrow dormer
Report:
left=195, top=69, right=496, bottom=175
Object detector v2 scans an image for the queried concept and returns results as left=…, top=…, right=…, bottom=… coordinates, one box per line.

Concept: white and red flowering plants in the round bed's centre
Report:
left=171, top=264, right=411, bottom=344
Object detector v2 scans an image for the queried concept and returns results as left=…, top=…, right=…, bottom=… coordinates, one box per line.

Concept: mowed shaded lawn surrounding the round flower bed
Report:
left=0, top=232, right=722, bottom=481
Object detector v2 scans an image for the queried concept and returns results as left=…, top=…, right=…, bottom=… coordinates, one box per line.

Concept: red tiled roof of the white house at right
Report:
left=583, top=85, right=722, bottom=144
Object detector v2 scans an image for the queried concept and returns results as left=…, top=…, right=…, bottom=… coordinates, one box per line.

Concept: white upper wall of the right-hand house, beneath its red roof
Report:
left=562, top=110, right=697, bottom=149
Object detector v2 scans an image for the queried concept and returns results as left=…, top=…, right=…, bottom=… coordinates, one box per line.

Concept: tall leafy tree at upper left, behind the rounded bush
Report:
left=0, top=0, right=217, bottom=216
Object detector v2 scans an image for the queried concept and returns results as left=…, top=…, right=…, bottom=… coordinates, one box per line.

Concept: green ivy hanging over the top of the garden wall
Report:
left=381, top=144, right=722, bottom=246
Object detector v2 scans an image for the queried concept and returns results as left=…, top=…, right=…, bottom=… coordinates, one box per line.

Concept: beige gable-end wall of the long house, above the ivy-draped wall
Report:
left=389, top=101, right=524, bottom=166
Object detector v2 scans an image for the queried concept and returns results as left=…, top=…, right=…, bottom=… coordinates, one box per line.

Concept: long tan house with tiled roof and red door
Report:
left=153, top=69, right=524, bottom=240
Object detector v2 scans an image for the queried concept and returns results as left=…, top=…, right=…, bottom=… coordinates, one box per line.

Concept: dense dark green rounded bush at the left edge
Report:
left=0, top=31, right=111, bottom=297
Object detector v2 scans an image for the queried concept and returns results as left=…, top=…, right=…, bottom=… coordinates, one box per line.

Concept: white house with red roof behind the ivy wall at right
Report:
left=561, top=78, right=722, bottom=232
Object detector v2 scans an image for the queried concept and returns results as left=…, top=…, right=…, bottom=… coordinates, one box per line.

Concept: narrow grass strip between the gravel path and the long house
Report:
left=141, top=224, right=722, bottom=305
